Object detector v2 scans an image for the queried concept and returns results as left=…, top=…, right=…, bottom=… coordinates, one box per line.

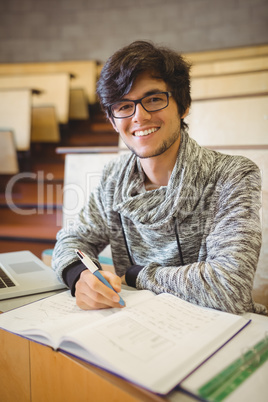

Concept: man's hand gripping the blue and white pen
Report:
left=75, top=269, right=123, bottom=310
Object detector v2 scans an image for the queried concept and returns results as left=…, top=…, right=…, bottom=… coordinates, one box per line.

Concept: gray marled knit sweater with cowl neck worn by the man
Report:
left=53, top=133, right=266, bottom=313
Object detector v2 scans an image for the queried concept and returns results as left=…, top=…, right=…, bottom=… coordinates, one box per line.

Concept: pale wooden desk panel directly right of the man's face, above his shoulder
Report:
left=185, top=96, right=268, bottom=147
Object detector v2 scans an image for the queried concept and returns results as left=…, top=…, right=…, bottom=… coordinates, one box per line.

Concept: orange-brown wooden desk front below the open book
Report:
left=0, top=330, right=193, bottom=402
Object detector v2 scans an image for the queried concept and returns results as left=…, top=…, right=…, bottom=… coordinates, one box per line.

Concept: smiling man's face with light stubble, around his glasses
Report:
left=111, top=72, right=186, bottom=158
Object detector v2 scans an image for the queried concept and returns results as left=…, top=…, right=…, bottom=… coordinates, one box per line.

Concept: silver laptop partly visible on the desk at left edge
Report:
left=0, top=251, right=66, bottom=300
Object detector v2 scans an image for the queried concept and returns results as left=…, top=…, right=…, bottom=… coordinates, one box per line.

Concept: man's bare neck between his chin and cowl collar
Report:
left=140, top=141, right=179, bottom=190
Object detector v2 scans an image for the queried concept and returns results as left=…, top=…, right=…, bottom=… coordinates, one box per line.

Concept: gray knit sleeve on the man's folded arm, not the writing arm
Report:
left=136, top=167, right=266, bottom=314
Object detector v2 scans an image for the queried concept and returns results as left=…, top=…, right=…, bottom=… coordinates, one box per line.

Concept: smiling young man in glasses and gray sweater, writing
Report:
left=53, top=41, right=265, bottom=313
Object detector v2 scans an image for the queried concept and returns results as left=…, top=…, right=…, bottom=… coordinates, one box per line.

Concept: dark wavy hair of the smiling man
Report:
left=97, top=41, right=191, bottom=128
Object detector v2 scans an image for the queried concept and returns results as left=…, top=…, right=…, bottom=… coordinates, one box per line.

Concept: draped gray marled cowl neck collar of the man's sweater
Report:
left=113, top=132, right=214, bottom=229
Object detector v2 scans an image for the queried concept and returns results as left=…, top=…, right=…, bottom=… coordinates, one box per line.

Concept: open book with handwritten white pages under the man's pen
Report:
left=0, top=288, right=254, bottom=395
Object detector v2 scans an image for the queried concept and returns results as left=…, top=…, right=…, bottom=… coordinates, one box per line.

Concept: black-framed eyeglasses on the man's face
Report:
left=109, top=92, right=172, bottom=119
